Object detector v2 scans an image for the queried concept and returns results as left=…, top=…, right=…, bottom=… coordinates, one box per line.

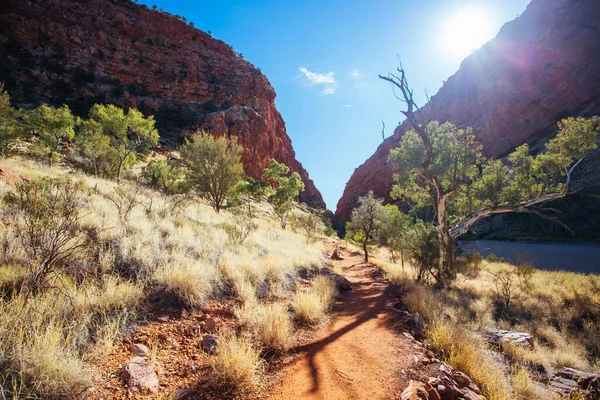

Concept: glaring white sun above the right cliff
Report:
left=440, top=8, right=495, bottom=58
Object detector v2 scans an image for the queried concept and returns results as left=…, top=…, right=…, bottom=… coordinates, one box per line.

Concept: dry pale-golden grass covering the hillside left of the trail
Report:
left=0, top=158, right=328, bottom=398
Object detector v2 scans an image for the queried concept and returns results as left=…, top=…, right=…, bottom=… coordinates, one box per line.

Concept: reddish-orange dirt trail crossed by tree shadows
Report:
left=272, top=244, right=414, bottom=400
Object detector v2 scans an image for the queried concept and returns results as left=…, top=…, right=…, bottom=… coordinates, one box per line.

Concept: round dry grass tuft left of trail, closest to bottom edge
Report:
left=210, top=336, right=265, bottom=392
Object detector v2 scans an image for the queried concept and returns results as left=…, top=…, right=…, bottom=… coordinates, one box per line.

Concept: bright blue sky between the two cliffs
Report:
left=140, top=0, right=529, bottom=210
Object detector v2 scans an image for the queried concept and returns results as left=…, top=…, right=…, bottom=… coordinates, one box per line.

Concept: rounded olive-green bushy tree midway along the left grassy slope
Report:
left=179, top=132, right=244, bottom=212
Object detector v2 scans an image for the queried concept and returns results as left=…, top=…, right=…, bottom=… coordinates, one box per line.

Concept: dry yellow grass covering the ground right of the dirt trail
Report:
left=376, top=252, right=600, bottom=399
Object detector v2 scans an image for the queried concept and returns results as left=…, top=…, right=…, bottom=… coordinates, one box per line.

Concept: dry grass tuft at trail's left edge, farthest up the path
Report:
left=292, top=275, right=336, bottom=324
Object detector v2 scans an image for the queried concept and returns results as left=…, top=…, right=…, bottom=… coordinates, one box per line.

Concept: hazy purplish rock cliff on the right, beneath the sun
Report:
left=336, top=0, right=600, bottom=221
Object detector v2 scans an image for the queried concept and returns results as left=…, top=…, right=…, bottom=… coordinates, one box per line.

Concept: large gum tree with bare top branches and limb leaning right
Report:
left=380, top=68, right=600, bottom=283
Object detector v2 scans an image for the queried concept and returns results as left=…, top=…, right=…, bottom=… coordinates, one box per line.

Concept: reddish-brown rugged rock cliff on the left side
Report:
left=0, top=0, right=325, bottom=208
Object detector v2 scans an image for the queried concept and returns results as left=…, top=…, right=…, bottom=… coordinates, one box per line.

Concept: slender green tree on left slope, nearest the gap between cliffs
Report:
left=262, top=159, right=304, bottom=229
